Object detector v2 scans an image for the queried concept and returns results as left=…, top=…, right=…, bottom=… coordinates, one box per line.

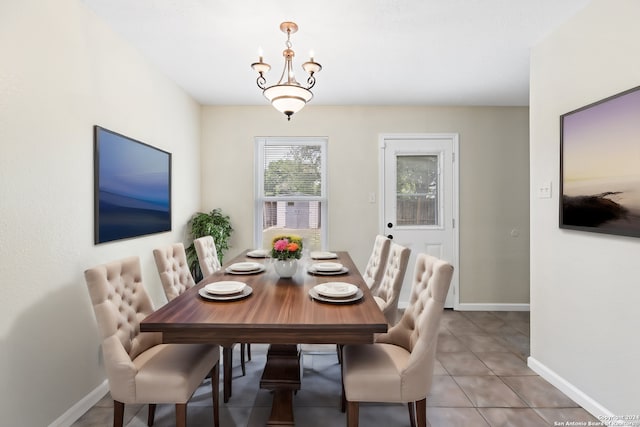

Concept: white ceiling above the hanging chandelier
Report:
left=83, top=0, right=590, bottom=106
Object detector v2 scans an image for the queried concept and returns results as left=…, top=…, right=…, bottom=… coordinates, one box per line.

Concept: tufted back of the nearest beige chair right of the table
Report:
left=376, top=253, right=453, bottom=402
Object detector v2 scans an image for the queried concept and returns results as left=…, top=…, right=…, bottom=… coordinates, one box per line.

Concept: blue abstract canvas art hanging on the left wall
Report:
left=94, top=126, right=171, bottom=244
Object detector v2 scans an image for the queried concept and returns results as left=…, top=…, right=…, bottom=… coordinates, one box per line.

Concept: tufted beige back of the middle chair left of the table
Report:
left=153, top=243, right=195, bottom=301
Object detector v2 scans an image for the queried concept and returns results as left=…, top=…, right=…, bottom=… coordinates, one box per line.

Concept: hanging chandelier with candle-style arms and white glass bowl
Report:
left=251, top=22, right=322, bottom=120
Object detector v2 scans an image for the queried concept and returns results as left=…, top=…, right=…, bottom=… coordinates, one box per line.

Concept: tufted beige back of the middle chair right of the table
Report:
left=373, top=243, right=411, bottom=325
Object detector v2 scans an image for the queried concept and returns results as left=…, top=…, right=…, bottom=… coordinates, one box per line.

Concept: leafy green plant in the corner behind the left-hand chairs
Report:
left=186, top=208, right=233, bottom=281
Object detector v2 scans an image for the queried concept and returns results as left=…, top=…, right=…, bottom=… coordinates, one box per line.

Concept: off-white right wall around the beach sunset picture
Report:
left=530, top=0, right=640, bottom=415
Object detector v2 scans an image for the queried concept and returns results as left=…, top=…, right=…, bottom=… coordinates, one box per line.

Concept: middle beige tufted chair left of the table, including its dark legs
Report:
left=153, top=243, right=245, bottom=402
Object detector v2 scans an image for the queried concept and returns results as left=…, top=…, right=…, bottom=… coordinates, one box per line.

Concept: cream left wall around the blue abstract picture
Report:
left=0, top=0, right=200, bottom=426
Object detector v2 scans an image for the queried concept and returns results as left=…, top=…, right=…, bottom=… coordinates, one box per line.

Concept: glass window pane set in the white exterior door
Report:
left=396, top=155, right=440, bottom=226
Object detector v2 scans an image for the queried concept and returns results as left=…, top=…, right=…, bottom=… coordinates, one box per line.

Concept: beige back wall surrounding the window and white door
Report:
left=201, top=105, right=529, bottom=308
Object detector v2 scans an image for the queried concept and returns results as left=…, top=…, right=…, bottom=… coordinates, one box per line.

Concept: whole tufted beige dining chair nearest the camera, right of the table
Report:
left=342, top=254, right=453, bottom=427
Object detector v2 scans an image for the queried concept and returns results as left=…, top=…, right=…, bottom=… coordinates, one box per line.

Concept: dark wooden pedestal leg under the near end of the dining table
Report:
left=260, top=344, right=300, bottom=426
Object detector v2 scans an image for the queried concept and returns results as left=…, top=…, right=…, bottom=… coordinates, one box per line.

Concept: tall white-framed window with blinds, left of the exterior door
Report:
left=254, top=138, right=327, bottom=250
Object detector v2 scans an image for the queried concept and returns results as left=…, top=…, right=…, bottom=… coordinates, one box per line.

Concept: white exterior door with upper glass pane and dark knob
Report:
left=380, top=134, right=459, bottom=308
